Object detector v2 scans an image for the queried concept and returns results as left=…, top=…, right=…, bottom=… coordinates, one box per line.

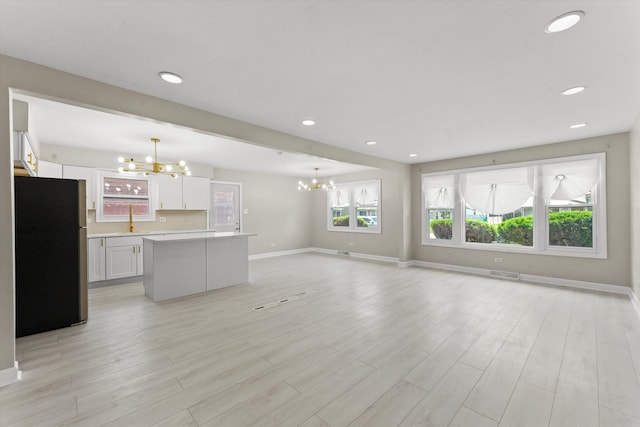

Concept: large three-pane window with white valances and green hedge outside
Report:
left=422, top=153, right=606, bottom=258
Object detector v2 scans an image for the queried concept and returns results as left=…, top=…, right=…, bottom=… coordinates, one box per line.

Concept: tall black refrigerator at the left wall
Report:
left=14, top=176, right=87, bottom=337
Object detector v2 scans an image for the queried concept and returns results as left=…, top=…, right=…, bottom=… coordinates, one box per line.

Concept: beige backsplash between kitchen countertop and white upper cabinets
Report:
left=87, top=210, right=207, bottom=235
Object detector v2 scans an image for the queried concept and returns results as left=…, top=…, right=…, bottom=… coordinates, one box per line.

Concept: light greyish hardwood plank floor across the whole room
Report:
left=0, top=254, right=640, bottom=427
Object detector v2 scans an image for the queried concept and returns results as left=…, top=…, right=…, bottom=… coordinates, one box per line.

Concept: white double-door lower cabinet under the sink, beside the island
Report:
left=105, top=236, right=142, bottom=280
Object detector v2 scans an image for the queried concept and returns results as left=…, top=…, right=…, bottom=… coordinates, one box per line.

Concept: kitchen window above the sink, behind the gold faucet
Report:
left=96, top=172, right=155, bottom=222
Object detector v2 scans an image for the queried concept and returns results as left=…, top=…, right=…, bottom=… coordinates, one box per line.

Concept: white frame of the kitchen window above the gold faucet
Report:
left=96, top=170, right=156, bottom=222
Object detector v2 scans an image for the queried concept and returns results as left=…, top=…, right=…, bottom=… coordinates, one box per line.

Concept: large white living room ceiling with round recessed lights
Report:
left=0, top=0, right=640, bottom=169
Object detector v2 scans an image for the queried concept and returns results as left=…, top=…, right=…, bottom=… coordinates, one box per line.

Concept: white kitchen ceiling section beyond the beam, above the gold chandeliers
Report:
left=14, top=95, right=372, bottom=178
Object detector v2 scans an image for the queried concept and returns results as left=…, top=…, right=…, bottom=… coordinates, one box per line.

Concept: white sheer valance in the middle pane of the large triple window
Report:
left=462, top=166, right=533, bottom=215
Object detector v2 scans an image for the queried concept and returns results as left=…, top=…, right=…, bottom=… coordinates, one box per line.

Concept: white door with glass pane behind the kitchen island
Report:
left=209, top=182, right=242, bottom=232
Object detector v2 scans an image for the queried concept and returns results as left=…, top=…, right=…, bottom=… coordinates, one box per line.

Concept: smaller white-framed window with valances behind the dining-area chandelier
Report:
left=327, top=180, right=381, bottom=233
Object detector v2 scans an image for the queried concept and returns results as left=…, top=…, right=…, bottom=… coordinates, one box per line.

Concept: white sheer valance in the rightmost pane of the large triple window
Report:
left=540, top=159, right=600, bottom=203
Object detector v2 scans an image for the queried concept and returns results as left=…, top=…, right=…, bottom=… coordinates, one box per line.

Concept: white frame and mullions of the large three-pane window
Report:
left=420, top=153, right=607, bottom=259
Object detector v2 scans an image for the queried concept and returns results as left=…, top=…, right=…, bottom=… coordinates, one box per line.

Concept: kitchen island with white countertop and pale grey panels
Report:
left=143, top=232, right=255, bottom=301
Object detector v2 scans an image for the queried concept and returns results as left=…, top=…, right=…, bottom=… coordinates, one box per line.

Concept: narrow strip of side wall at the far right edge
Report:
left=629, top=116, right=640, bottom=298
